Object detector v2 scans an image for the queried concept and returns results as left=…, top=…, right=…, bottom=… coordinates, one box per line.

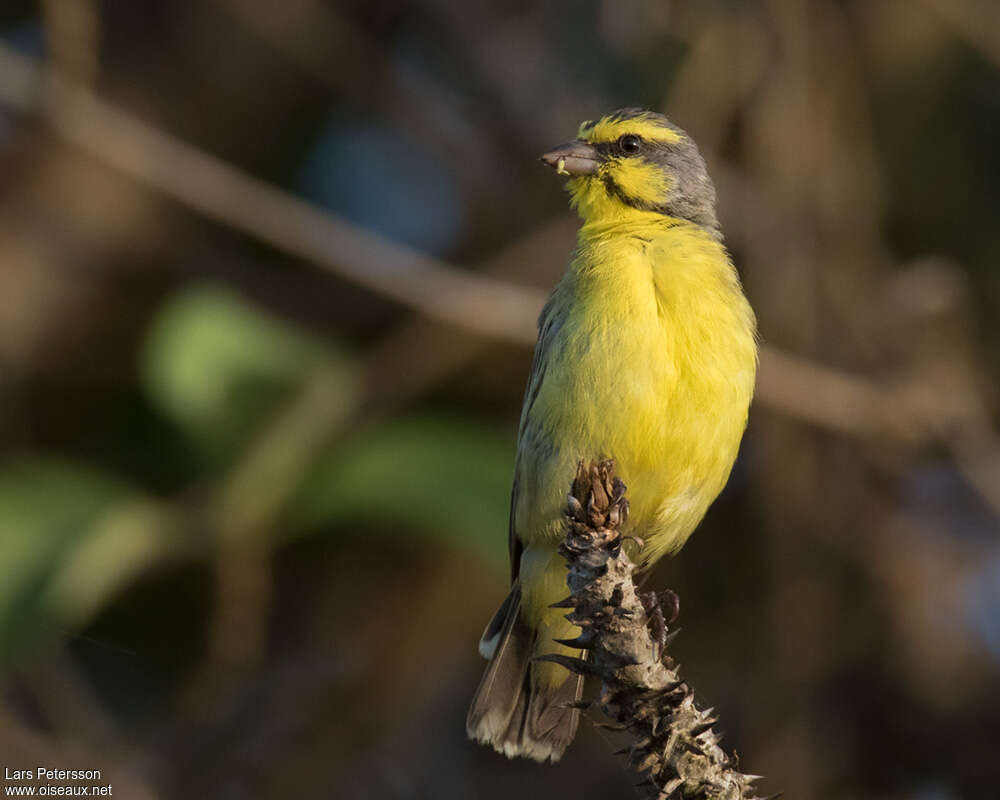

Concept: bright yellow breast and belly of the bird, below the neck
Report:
left=514, top=215, right=757, bottom=559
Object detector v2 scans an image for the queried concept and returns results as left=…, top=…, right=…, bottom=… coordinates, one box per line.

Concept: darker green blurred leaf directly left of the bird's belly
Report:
left=291, top=417, right=514, bottom=565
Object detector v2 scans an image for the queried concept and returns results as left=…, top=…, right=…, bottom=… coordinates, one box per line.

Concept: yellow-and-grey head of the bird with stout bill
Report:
left=542, top=108, right=719, bottom=235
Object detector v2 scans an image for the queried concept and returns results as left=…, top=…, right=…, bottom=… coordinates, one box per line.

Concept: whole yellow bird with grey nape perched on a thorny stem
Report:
left=467, top=109, right=757, bottom=761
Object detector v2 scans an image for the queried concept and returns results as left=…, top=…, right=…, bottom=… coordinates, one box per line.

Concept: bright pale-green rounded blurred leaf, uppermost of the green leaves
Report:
left=142, top=285, right=356, bottom=465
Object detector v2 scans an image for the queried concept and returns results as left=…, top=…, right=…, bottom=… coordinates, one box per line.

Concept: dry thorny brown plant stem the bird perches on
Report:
left=545, top=461, right=759, bottom=800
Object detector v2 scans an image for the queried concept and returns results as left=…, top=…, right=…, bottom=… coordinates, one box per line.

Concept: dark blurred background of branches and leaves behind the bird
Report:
left=0, top=0, right=1000, bottom=800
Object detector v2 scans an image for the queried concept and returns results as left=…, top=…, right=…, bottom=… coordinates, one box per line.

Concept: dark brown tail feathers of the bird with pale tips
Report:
left=465, top=583, right=583, bottom=761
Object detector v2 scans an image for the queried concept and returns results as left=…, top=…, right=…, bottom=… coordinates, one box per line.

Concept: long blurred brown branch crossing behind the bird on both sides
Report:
left=0, top=46, right=1000, bottom=507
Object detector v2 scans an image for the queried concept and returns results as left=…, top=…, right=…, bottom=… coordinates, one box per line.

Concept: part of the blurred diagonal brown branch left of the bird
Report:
left=0, top=46, right=544, bottom=344
